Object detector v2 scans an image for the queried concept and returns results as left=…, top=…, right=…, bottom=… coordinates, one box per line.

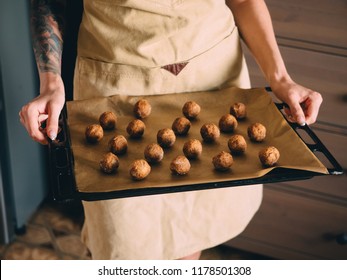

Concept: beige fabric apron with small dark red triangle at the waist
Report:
left=74, top=0, right=262, bottom=259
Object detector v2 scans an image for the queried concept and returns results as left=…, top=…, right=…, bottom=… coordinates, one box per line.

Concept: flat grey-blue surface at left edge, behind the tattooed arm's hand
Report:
left=0, top=0, right=47, bottom=242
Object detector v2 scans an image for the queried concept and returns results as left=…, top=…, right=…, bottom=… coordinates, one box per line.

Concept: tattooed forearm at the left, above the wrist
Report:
left=30, top=0, right=65, bottom=74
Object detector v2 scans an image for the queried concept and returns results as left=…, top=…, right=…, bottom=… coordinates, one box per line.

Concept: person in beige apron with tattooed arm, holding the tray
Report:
left=19, top=0, right=322, bottom=259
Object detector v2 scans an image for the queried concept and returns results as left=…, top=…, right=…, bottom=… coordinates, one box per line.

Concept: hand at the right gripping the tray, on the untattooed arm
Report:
left=271, top=76, right=323, bottom=125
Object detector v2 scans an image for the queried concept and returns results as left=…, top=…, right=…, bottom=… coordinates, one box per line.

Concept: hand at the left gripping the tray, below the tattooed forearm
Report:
left=19, top=74, right=65, bottom=144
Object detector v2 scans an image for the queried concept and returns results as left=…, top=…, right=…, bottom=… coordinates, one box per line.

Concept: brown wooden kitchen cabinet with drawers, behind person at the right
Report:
left=226, top=0, right=347, bottom=259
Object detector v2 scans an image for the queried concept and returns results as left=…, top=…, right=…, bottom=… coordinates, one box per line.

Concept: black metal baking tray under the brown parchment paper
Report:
left=48, top=88, right=343, bottom=201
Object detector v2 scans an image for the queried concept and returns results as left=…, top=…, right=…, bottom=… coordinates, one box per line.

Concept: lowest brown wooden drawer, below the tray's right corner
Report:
left=227, top=187, right=347, bottom=259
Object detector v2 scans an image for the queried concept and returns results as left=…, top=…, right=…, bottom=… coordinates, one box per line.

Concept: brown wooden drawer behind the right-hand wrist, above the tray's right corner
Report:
left=245, top=46, right=347, bottom=127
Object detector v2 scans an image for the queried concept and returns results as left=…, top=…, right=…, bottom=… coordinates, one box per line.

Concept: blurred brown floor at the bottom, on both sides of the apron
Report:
left=0, top=201, right=267, bottom=260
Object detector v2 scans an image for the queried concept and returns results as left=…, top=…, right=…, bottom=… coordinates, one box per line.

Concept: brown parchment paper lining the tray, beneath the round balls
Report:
left=67, top=88, right=328, bottom=193
